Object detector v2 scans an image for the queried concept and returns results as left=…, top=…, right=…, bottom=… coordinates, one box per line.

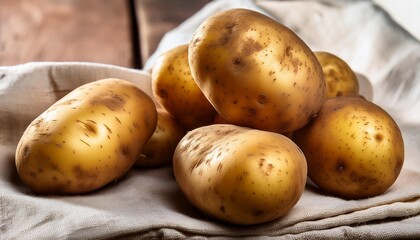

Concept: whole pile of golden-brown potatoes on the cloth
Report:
left=16, top=9, right=404, bottom=225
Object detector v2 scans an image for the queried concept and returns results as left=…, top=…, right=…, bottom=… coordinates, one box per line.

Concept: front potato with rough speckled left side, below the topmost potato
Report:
left=173, top=124, right=307, bottom=225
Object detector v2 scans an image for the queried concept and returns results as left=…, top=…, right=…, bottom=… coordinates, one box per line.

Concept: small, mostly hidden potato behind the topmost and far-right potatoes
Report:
left=314, top=52, right=359, bottom=98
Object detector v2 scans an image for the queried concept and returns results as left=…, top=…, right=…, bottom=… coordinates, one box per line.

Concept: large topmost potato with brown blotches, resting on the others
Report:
left=188, top=9, right=325, bottom=133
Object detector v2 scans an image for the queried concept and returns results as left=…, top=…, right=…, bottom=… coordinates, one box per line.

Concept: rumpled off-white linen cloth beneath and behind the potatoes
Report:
left=0, top=0, right=420, bottom=240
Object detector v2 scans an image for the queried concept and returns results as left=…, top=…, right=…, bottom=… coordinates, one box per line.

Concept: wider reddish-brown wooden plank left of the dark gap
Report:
left=0, top=0, right=133, bottom=67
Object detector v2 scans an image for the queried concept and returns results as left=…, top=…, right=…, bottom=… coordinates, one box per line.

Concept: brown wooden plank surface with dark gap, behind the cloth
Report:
left=0, top=0, right=210, bottom=68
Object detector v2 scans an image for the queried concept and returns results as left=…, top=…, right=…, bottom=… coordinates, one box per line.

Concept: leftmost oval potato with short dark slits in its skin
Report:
left=16, top=79, right=157, bottom=194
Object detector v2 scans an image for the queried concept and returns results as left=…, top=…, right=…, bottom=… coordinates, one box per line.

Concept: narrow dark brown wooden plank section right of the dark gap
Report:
left=135, top=0, right=210, bottom=63
